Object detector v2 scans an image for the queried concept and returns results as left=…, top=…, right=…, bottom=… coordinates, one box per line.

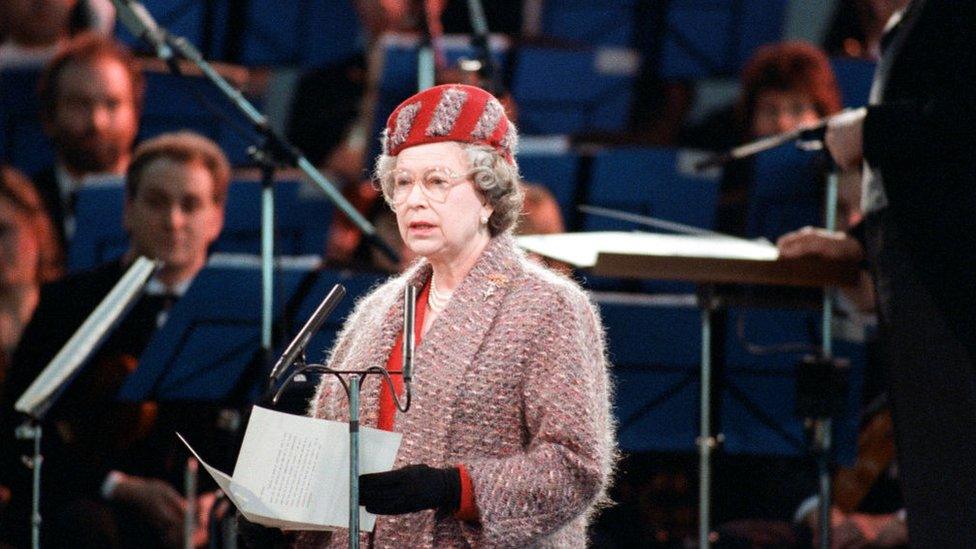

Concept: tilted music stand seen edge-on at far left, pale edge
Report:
left=14, top=257, right=156, bottom=549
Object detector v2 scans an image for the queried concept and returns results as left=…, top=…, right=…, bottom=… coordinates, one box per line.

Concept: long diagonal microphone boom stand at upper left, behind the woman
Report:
left=112, top=0, right=400, bottom=364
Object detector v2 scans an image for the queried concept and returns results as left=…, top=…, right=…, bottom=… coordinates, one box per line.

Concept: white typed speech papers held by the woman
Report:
left=177, top=406, right=401, bottom=532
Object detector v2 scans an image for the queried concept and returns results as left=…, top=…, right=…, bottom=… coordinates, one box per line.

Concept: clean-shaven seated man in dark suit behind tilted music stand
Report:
left=0, top=132, right=230, bottom=547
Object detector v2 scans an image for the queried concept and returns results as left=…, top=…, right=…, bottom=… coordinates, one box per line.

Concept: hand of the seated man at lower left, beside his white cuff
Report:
left=112, top=475, right=186, bottom=547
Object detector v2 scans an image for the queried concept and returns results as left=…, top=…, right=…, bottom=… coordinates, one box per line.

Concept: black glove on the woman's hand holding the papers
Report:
left=359, top=464, right=461, bottom=515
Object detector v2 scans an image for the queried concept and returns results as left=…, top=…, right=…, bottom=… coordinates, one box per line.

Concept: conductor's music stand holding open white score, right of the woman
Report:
left=518, top=232, right=858, bottom=547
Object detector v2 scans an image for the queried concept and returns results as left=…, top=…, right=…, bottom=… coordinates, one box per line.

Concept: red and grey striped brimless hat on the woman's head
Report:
left=383, top=84, right=518, bottom=164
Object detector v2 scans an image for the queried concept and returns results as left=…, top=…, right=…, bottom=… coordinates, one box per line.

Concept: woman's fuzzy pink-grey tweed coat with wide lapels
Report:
left=297, top=235, right=616, bottom=548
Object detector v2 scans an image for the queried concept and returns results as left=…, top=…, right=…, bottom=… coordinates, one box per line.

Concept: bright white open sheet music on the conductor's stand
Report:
left=517, top=231, right=779, bottom=268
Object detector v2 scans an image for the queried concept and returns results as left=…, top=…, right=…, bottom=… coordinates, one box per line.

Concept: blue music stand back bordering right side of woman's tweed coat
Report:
left=597, top=296, right=701, bottom=452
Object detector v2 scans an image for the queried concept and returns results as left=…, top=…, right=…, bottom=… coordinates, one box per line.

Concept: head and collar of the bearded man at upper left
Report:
left=32, top=33, right=145, bottom=243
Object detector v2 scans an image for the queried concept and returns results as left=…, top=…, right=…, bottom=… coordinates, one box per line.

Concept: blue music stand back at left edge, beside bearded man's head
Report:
left=0, top=68, right=54, bottom=175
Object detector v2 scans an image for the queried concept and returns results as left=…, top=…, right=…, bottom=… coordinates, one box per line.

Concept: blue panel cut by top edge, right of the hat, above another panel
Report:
left=542, top=0, right=637, bottom=48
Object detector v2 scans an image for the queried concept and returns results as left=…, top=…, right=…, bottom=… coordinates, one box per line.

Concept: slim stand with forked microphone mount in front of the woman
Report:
left=271, top=284, right=417, bottom=549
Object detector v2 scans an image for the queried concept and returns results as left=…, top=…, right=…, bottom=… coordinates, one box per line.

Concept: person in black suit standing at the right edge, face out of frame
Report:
left=826, top=0, right=976, bottom=547
